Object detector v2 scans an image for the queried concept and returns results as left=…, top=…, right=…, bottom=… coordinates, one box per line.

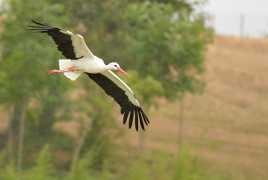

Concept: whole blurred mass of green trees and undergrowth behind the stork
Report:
left=0, top=0, right=220, bottom=180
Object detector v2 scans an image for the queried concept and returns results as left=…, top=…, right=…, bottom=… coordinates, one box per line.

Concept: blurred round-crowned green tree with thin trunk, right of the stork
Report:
left=121, top=1, right=212, bottom=153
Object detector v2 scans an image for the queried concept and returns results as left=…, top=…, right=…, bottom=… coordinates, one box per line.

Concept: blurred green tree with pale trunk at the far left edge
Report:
left=0, top=0, right=68, bottom=169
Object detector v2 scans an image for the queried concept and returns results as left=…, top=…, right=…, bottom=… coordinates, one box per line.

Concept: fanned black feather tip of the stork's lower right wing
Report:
left=121, top=106, right=150, bottom=132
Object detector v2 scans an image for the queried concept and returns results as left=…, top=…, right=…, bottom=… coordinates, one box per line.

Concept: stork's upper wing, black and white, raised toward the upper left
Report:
left=29, top=20, right=94, bottom=60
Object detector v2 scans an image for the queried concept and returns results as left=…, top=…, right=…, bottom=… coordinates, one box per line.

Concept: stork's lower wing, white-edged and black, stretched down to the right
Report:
left=87, top=71, right=150, bottom=131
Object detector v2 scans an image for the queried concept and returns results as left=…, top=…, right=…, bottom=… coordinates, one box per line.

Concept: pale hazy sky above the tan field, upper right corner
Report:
left=205, top=0, right=268, bottom=37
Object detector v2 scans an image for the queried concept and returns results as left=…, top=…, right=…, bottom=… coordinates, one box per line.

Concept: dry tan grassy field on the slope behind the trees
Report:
left=0, top=37, right=268, bottom=179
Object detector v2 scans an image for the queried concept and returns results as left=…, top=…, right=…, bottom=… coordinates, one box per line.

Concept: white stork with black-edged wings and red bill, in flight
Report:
left=29, top=20, right=150, bottom=131
